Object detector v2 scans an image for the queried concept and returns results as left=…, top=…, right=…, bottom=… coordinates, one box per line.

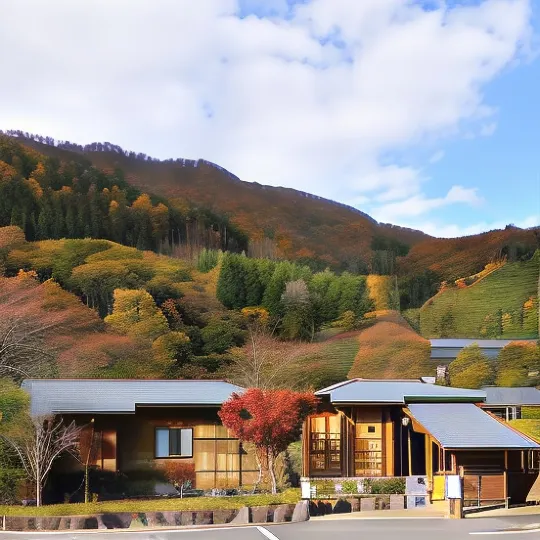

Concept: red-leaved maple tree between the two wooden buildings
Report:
left=219, top=388, right=317, bottom=493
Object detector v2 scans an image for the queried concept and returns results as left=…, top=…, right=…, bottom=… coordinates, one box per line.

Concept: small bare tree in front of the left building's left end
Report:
left=0, top=416, right=80, bottom=506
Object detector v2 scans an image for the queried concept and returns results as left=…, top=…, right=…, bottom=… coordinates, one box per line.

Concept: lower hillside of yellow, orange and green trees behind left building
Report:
left=0, top=226, right=397, bottom=385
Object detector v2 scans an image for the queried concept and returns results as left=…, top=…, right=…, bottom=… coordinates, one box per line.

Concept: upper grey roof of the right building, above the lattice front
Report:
left=316, top=379, right=486, bottom=404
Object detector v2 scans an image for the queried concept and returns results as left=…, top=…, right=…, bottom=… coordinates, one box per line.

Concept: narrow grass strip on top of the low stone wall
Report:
left=0, top=489, right=300, bottom=517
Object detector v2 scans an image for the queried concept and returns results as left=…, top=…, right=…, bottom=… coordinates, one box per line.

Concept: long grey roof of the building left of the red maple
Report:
left=22, top=379, right=243, bottom=415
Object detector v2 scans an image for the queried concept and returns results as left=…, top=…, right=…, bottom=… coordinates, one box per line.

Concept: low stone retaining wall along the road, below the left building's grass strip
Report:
left=0, top=501, right=309, bottom=531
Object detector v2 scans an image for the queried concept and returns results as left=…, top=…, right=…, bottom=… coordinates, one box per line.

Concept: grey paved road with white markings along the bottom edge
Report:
left=0, top=515, right=540, bottom=540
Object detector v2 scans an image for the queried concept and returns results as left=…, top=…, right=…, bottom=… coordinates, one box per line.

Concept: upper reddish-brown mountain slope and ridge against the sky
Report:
left=0, top=132, right=536, bottom=278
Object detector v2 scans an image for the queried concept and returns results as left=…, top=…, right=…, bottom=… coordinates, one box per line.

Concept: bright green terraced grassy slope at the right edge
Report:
left=420, top=257, right=539, bottom=338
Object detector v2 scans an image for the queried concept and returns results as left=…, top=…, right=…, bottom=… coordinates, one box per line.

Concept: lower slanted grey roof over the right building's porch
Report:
left=409, top=403, right=540, bottom=449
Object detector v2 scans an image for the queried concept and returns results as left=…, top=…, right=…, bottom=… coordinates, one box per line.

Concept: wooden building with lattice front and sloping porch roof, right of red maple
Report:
left=303, top=379, right=540, bottom=506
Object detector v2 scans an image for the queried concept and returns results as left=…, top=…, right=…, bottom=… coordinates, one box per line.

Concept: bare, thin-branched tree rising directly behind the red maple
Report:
left=227, top=325, right=314, bottom=390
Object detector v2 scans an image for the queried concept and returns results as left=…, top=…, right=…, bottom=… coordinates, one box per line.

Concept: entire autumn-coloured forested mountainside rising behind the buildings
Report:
left=0, top=133, right=539, bottom=387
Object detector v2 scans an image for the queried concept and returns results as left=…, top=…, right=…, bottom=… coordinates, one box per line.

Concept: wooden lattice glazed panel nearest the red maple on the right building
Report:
left=309, top=415, right=341, bottom=476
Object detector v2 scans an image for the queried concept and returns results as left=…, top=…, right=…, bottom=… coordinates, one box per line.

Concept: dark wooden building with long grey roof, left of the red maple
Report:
left=23, top=379, right=258, bottom=498
